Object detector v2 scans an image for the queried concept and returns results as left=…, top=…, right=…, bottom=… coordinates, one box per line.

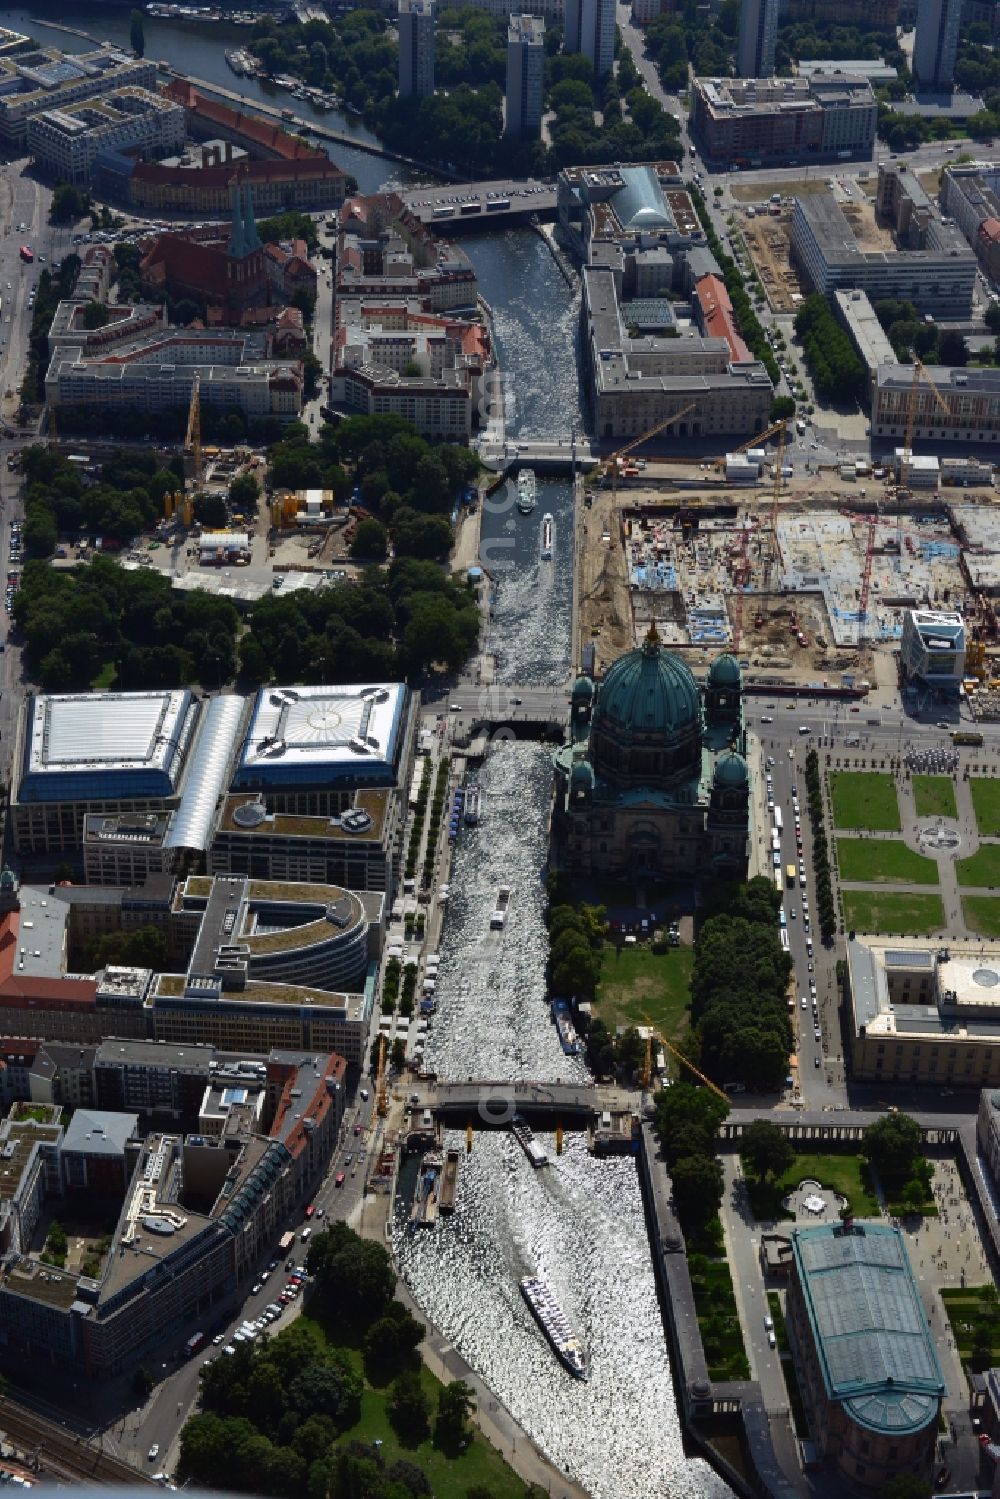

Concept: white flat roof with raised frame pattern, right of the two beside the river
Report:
left=232, top=682, right=409, bottom=790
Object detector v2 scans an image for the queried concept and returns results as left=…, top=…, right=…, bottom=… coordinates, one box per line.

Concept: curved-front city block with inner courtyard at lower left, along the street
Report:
left=0, top=1049, right=345, bottom=1381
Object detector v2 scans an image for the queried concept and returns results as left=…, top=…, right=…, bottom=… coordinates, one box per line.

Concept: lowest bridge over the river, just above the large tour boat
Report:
left=409, top=1078, right=640, bottom=1129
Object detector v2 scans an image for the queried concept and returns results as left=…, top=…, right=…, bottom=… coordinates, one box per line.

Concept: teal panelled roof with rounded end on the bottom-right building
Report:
left=792, top=1222, right=946, bottom=1435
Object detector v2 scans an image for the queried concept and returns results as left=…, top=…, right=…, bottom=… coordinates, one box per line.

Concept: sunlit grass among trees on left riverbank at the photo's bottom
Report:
left=296, top=1313, right=530, bottom=1499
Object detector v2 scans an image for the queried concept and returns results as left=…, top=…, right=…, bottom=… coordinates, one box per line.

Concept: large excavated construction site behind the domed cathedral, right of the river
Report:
left=577, top=465, right=1000, bottom=685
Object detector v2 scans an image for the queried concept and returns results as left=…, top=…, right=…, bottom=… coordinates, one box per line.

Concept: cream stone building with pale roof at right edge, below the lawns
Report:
left=847, top=935, right=1000, bottom=1088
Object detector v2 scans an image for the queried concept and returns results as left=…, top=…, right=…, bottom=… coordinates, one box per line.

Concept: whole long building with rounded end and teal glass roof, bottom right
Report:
left=786, top=1219, right=946, bottom=1493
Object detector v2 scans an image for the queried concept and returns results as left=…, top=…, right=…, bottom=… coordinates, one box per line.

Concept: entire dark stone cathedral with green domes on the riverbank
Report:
left=553, top=630, right=750, bottom=881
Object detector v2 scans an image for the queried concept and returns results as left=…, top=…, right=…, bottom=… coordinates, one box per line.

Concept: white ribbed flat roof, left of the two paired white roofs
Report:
left=18, top=688, right=196, bottom=802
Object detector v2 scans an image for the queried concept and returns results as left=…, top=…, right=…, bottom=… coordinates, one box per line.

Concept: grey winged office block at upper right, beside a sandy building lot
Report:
left=792, top=193, right=976, bottom=316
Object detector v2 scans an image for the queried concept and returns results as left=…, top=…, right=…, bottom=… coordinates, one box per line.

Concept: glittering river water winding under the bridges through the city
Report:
left=0, top=3, right=729, bottom=1499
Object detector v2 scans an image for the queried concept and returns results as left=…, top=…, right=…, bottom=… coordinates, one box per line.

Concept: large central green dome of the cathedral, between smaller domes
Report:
left=595, top=630, right=702, bottom=742
